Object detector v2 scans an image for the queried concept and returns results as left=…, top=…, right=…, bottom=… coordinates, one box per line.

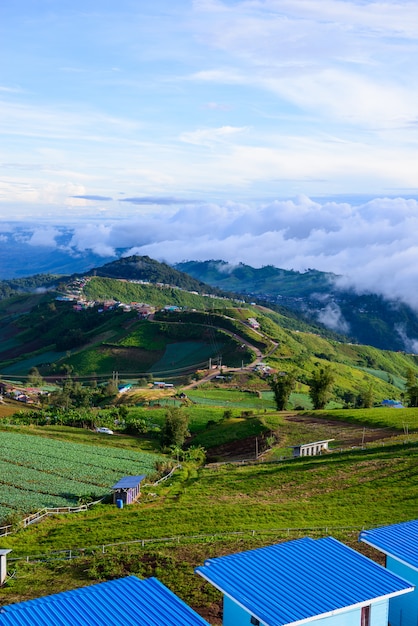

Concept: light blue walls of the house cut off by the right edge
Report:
left=386, top=556, right=418, bottom=626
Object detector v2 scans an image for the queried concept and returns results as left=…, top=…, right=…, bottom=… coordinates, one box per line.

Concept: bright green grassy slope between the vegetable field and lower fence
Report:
left=2, top=445, right=418, bottom=555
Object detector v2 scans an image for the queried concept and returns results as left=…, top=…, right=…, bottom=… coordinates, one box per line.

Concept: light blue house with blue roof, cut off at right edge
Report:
left=359, top=519, right=418, bottom=626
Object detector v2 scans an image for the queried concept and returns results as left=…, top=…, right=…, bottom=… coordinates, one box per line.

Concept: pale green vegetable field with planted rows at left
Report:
left=0, top=432, right=160, bottom=522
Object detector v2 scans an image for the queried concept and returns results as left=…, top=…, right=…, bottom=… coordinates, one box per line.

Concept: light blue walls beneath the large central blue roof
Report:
left=222, top=594, right=388, bottom=626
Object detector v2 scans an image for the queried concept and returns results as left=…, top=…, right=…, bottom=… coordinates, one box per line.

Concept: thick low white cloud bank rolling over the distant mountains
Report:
left=0, top=196, right=418, bottom=310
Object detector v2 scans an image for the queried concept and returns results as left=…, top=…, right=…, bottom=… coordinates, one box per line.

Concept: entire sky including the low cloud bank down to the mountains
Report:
left=0, top=0, right=418, bottom=312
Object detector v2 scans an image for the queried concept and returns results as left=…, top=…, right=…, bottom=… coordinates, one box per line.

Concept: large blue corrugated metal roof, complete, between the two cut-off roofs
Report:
left=196, top=537, right=413, bottom=626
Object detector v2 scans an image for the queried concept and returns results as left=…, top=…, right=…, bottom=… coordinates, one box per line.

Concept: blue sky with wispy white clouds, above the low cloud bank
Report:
left=0, top=0, right=418, bottom=216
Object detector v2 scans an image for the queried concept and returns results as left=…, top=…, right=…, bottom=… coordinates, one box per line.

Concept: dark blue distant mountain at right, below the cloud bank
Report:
left=174, top=260, right=418, bottom=353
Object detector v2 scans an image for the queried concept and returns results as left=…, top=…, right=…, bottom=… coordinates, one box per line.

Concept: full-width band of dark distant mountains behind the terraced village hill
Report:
left=0, top=256, right=418, bottom=353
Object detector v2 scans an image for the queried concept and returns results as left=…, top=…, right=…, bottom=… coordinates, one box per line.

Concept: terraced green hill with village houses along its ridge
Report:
left=0, top=251, right=418, bottom=408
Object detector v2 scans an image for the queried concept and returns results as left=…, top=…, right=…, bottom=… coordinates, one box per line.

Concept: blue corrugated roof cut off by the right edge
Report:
left=359, top=520, right=418, bottom=570
